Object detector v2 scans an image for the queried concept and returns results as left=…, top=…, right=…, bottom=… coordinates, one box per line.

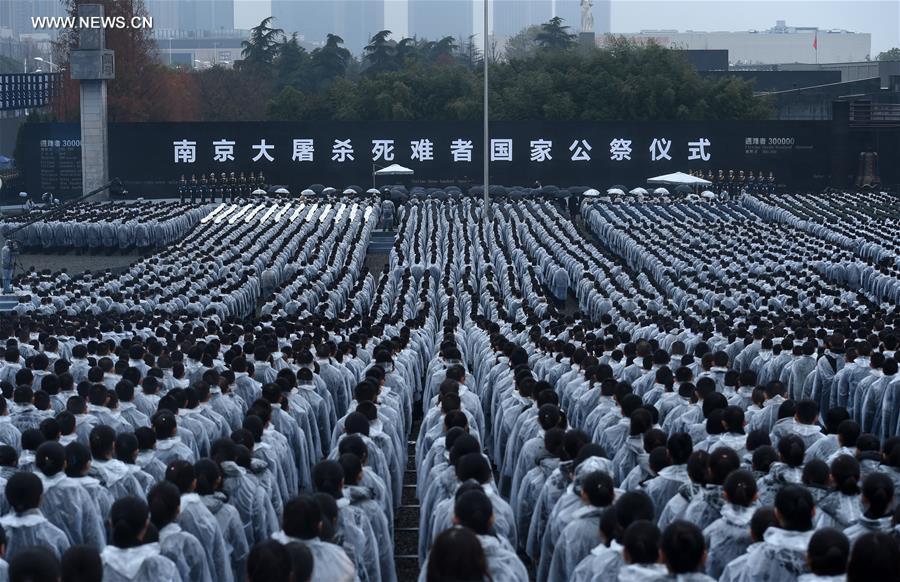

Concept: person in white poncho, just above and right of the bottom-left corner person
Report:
left=35, top=442, right=106, bottom=547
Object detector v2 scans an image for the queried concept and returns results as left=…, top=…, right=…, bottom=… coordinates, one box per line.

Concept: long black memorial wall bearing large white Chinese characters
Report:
left=17, top=121, right=840, bottom=196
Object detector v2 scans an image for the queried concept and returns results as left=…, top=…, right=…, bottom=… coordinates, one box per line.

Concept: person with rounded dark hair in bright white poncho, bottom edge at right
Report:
left=745, top=484, right=816, bottom=580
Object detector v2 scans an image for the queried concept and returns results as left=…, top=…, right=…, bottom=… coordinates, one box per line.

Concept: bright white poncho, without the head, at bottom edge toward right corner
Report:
left=745, top=527, right=814, bottom=582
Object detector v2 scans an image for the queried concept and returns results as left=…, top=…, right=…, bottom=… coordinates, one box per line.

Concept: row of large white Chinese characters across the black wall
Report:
left=172, top=137, right=712, bottom=164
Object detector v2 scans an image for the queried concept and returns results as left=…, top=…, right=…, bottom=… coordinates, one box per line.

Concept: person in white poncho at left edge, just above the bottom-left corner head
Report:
left=0, top=472, right=71, bottom=569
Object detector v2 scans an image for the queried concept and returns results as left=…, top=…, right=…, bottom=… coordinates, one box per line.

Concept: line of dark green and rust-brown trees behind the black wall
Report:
left=42, top=0, right=770, bottom=121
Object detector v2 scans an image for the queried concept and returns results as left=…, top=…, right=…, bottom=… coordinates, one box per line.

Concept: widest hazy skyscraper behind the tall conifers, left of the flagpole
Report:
left=272, top=0, right=385, bottom=54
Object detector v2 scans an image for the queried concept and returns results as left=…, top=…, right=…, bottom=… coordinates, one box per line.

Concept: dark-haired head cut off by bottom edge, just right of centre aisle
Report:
left=424, top=527, right=490, bottom=582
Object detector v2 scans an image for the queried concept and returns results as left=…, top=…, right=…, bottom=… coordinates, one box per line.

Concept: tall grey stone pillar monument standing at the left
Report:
left=69, top=4, right=116, bottom=199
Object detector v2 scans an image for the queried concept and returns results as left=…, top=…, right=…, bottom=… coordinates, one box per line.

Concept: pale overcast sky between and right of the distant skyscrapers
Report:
left=235, top=0, right=900, bottom=55
